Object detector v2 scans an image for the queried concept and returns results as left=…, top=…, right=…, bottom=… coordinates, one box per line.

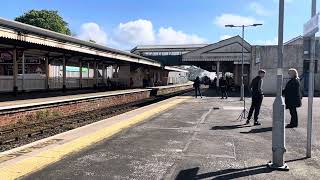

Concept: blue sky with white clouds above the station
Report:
left=0, top=0, right=320, bottom=50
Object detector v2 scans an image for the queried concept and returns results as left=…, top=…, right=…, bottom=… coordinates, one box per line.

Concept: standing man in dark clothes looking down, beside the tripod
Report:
left=246, top=69, right=266, bottom=126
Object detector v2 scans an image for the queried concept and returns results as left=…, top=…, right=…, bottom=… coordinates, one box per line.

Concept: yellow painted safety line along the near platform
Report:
left=0, top=98, right=188, bottom=180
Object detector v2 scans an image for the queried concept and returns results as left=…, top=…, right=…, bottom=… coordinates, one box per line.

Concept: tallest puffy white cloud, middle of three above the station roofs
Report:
left=114, top=19, right=155, bottom=45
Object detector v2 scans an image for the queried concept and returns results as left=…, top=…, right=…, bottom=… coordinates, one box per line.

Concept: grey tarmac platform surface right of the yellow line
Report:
left=3, top=92, right=320, bottom=180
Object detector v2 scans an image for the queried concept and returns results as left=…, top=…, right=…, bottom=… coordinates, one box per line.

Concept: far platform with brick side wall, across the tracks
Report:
left=0, top=83, right=192, bottom=128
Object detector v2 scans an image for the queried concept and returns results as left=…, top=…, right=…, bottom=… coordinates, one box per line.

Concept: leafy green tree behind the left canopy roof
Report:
left=15, top=10, right=71, bottom=35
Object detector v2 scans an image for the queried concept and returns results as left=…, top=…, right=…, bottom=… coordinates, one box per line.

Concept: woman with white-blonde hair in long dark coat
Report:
left=282, top=68, right=302, bottom=128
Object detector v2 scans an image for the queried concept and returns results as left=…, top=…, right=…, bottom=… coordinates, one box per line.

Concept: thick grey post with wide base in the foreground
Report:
left=268, top=0, right=289, bottom=171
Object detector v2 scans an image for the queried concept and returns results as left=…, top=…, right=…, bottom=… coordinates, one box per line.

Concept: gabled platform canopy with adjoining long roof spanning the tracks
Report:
left=131, top=36, right=251, bottom=90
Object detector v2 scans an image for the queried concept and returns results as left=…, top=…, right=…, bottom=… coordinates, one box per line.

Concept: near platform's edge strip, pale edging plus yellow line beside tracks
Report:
left=0, top=97, right=188, bottom=180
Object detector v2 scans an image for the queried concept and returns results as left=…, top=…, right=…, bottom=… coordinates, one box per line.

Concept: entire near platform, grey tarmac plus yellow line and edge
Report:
left=0, top=90, right=320, bottom=180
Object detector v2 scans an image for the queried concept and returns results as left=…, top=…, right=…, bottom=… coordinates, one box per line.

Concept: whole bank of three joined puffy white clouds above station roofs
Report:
left=77, top=19, right=207, bottom=50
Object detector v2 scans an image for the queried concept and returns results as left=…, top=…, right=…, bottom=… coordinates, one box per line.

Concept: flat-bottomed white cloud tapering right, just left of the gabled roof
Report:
left=157, top=27, right=207, bottom=44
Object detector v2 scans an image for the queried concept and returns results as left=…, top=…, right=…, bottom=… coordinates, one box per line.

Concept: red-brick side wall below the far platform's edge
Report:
left=0, top=91, right=150, bottom=127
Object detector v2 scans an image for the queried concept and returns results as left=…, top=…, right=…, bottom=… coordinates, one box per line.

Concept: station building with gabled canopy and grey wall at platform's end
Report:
left=131, top=36, right=320, bottom=94
